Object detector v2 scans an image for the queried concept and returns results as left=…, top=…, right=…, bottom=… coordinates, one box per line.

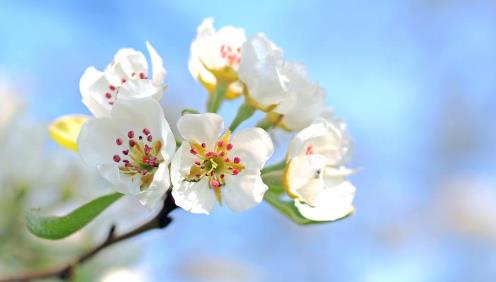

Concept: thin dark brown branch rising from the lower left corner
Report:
left=0, top=193, right=177, bottom=282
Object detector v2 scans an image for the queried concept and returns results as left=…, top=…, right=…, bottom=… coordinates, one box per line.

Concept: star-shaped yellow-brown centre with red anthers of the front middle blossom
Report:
left=184, top=130, right=245, bottom=204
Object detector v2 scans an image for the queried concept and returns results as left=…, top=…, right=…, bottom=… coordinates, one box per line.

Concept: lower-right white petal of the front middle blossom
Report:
left=223, top=170, right=268, bottom=212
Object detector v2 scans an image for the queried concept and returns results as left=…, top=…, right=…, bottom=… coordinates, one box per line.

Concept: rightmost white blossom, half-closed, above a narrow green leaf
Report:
left=284, top=119, right=355, bottom=221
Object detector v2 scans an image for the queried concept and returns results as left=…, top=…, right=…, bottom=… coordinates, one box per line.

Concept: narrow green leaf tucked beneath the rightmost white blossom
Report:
left=264, top=187, right=353, bottom=225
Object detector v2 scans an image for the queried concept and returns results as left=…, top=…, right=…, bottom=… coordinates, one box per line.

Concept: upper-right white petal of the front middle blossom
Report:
left=230, top=128, right=274, bottom=170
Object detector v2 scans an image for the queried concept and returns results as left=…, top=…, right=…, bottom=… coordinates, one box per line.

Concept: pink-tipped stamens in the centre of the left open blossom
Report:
left=112, top=128, right=164, bottom=191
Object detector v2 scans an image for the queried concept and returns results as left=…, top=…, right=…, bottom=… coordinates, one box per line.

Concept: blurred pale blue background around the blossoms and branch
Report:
left=0, top=0, right=496, bottom=282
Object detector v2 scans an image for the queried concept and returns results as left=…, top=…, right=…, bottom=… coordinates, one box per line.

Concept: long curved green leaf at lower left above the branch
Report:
left=26, top=193, right=123, bottom=240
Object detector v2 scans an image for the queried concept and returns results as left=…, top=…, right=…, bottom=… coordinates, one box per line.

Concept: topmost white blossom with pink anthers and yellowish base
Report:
left=188, top=18, right=246, bottom=99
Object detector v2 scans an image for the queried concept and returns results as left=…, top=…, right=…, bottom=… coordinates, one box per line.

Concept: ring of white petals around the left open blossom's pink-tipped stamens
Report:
left=78, top=98, right=175, bottom=199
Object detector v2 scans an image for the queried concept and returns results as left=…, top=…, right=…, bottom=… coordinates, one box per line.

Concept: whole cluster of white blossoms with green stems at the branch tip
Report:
left=54, top=18, right=355, bottom=221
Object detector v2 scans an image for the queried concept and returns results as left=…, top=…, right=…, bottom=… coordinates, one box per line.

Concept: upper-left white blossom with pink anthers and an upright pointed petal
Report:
left=79, top=42, right=166, bottom=117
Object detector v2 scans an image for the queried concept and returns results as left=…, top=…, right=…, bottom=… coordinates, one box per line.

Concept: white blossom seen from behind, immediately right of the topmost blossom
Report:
left=238, top=33, right=288, bottom=111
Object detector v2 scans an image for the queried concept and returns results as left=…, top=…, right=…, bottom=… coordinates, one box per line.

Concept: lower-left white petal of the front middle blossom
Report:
left=172, top=177, right=216, bottom=214
